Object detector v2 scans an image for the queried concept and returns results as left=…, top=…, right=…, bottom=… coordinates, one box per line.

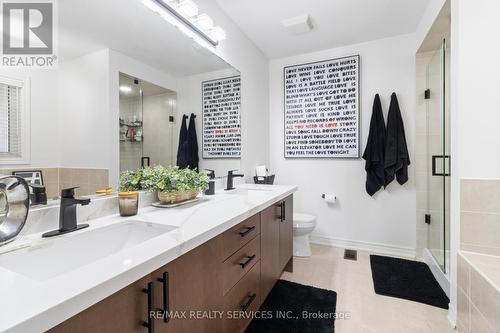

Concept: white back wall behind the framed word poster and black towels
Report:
left=269, top=35, right=416, bottom=256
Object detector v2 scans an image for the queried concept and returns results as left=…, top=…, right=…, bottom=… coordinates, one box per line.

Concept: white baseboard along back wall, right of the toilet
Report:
left=310, top=234, right=416, bottom=259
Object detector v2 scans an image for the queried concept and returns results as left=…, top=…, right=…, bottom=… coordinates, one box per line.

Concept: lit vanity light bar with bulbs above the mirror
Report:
left=142, top=0, right=226, bottom=47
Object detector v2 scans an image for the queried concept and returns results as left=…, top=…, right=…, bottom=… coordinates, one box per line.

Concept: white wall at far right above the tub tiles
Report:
left=452, top=0, right=500, bottom=179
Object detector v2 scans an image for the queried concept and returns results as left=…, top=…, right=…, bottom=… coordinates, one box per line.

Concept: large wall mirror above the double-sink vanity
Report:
left=0, top=0, right=240, bottom=198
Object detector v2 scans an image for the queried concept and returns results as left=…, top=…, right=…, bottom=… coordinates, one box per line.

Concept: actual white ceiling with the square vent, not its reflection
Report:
left=216, top=0, right=429, bottom=58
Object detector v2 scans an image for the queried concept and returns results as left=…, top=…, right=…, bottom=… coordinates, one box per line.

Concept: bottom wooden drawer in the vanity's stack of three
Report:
left=223, top=261, right=261, bottom=333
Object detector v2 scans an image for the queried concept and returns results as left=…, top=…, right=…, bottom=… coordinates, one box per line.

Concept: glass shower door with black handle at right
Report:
left=426, top=40, right=451, bottom=273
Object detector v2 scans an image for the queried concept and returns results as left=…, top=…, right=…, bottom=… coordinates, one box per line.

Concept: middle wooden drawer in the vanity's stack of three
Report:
left=222, top=233, right=260, bottom=294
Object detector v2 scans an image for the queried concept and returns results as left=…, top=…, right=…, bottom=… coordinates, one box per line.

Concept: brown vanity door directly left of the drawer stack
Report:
left=151, top=237, right=223, bottom=333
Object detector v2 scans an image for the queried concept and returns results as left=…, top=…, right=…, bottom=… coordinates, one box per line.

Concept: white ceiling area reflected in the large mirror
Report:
left=58, top=0, right=229, bottom=76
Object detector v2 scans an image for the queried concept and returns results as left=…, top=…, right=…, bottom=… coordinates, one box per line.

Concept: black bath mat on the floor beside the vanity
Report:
left=246, top=280, right=337, bottom=333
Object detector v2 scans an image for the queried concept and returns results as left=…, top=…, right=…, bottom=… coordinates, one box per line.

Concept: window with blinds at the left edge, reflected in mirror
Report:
left=0, top=76, right=29, bottom=164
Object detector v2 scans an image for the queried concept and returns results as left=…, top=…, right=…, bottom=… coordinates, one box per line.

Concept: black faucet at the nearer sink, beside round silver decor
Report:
left=42, top=187, right=90, bottom=237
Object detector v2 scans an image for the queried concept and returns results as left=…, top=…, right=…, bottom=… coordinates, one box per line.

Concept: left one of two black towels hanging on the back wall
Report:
left=363, top=94, right=386, bottom=196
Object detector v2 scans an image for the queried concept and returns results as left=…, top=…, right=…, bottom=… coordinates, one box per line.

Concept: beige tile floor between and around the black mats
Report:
left=282, top=244, right=456, bottom=333
